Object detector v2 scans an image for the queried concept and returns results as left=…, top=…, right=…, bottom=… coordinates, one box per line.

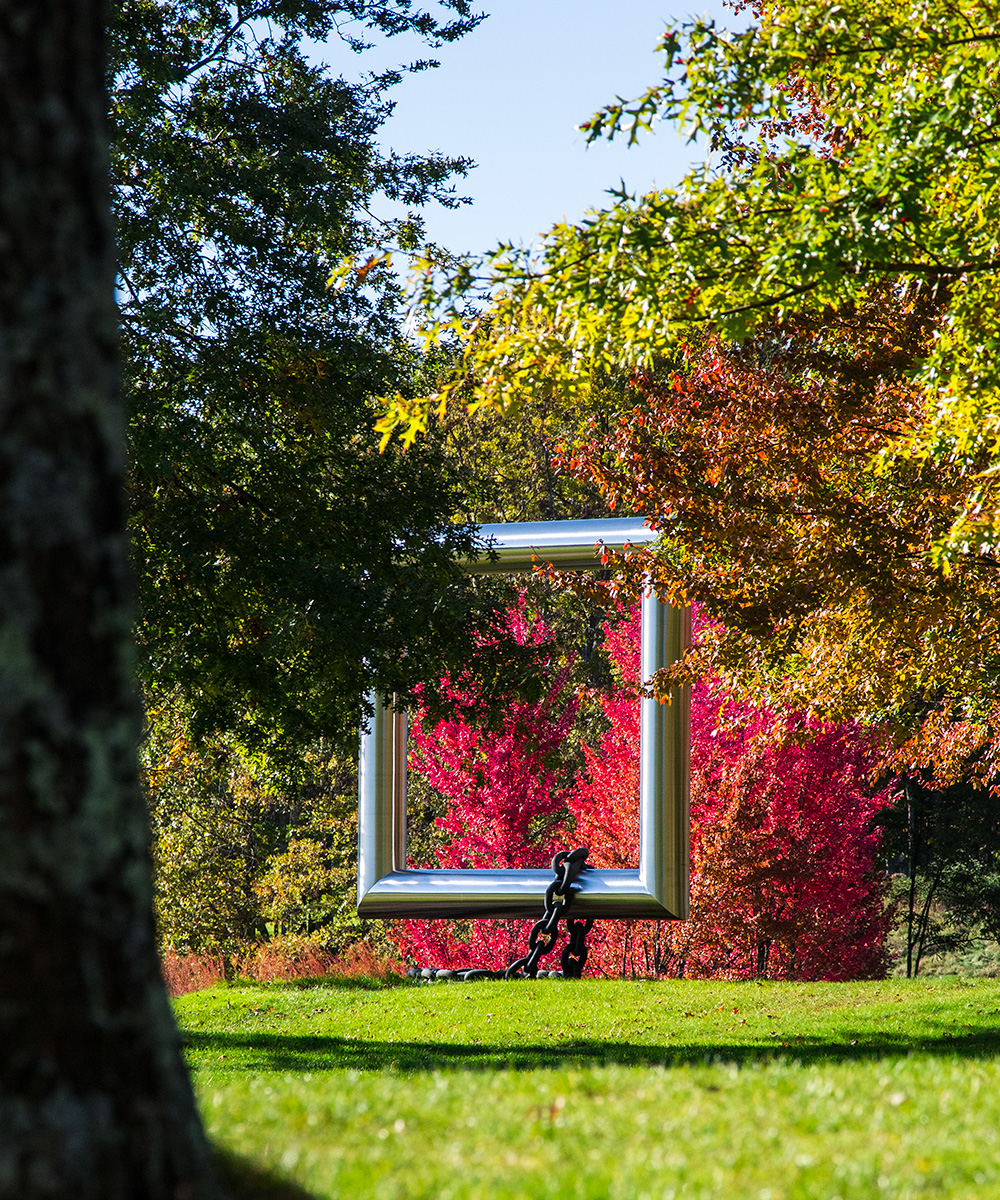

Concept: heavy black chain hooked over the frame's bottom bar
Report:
left=407, top=846, right=594, bottom=982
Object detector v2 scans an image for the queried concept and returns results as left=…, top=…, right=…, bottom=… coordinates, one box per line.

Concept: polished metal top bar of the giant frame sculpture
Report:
left=462, top=517, right=658, bottom=575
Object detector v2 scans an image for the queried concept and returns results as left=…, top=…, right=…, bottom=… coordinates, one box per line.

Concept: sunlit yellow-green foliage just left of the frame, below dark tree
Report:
left=142, top=697, right=370, bottom=964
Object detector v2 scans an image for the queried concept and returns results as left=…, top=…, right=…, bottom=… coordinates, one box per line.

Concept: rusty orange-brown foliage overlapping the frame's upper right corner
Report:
left=557, top=304, right=1000, bottom=784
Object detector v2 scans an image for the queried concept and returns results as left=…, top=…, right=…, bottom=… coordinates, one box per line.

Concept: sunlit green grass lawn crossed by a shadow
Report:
left=176, top=979, right=1000, bottom=1200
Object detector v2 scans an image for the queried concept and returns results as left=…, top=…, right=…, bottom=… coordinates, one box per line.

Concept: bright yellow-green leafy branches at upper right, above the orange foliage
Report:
left=383, top=0, right=1000, bottom=482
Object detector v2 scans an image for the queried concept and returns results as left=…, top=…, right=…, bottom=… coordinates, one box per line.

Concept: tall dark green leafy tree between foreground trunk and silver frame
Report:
left=110, top=0, right=499, bottom=764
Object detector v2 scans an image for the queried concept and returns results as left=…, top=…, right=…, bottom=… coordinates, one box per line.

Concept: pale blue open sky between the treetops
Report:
left=330, top=0, right=721, bottom=252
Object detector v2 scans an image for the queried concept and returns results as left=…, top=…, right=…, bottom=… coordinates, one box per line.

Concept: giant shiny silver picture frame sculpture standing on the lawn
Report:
left=358, top=518, right=690, bottom=920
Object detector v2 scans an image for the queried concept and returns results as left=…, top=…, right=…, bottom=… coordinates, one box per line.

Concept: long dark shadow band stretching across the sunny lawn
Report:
left=185, top=1026, right=1000, bottom=1074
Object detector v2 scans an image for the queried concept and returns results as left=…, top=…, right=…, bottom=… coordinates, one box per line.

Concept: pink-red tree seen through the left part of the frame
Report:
left=393, top=599, right=577, bottom=970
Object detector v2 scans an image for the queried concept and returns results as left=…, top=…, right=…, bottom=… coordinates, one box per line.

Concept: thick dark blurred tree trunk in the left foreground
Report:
left=0, top=0, right=217, bottom=1200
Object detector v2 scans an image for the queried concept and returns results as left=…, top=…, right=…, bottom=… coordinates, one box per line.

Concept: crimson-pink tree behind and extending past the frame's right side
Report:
left=570, top=604, right=888, bottom=979
